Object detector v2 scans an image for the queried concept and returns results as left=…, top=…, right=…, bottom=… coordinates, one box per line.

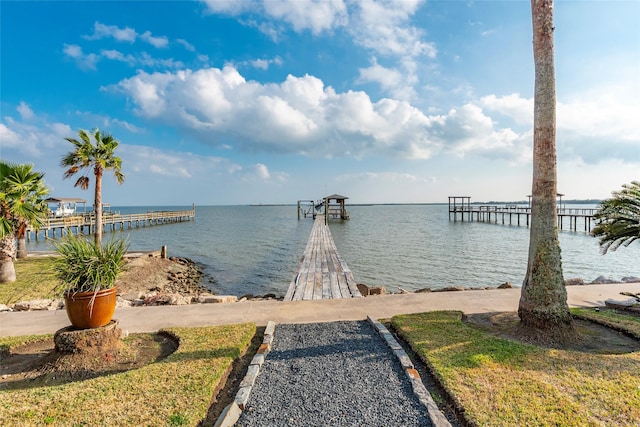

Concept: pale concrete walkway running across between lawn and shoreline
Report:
left=0, top=283, right=640, bottom=336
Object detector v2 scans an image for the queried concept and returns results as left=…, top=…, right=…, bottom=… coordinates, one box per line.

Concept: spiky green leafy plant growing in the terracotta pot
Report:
left=53, top=234, right=129, bottom=294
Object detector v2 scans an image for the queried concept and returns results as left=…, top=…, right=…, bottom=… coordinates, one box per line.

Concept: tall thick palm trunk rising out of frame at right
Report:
left=518, top=0, right=573, bottom=341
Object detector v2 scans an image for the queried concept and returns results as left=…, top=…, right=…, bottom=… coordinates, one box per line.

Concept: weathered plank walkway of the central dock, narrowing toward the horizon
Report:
left=284, top=215, right=362, bottom=301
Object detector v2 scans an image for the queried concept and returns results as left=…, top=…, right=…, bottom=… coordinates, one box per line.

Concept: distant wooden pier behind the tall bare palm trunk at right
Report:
left=449, top=194, right=598, bottom=233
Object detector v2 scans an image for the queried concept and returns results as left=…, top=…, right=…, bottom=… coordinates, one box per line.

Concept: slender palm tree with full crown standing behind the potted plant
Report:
left=60, top=129, right=124, bottom=246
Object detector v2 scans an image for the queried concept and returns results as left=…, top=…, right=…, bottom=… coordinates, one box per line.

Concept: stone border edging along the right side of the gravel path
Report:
left=367, top=316, right=451, bottom=427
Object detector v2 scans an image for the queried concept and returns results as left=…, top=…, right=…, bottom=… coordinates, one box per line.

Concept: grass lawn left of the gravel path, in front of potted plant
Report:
left=0, top=324, right=256, bottom=426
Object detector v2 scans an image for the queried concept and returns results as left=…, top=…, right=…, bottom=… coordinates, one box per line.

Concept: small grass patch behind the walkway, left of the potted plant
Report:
left=0, top=257, right=58, bottom=305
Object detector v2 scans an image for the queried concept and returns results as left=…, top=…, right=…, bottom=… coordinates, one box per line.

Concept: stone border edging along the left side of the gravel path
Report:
left=214, top=320, right=276, bottom=427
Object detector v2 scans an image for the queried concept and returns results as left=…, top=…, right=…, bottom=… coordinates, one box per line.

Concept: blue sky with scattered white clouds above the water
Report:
left=0, top=0, right=640, bottom=205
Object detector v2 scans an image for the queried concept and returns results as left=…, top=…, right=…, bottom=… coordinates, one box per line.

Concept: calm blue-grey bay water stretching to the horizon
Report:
left=29, top=205, right=640, bottom=295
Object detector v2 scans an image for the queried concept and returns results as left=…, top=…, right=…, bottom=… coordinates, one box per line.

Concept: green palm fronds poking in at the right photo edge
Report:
left=591, top=181, right=640, bottom=254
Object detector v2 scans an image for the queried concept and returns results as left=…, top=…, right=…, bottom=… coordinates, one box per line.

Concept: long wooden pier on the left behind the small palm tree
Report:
left=26, top=206, right=196, bottom=241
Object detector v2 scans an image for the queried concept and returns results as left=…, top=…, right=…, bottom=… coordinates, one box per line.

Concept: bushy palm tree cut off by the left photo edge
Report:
left=0, top=161, right=49, bottom=283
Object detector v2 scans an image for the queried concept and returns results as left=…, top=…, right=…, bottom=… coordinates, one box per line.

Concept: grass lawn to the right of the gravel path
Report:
left=392, top=310, right=640, bottom=427
